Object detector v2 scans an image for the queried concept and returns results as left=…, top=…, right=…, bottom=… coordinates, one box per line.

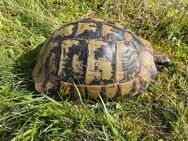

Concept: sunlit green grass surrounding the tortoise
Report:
left=0, top=0, right=188, bottom=141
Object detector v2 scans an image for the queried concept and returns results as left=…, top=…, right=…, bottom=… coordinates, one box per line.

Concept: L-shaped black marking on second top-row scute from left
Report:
left=76, top=22, right=102, bottom=39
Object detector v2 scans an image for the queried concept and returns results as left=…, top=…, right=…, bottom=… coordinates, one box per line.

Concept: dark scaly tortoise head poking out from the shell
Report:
left=154, top=52, right=171, bottom=70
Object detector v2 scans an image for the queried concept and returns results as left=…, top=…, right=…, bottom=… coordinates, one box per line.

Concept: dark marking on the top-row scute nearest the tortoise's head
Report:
left=129, top=32, right=144, bottom=50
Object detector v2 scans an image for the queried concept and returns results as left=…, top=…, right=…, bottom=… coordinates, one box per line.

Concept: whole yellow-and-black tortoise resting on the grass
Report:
left=33, top=18, right=170, bottom=99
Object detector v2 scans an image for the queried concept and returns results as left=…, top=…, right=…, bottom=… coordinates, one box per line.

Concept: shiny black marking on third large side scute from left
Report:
left=90, top=43, right=116, bottom=85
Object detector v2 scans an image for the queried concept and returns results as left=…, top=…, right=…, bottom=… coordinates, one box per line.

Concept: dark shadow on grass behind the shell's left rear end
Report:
left=13, top=42, right=44, bottom=92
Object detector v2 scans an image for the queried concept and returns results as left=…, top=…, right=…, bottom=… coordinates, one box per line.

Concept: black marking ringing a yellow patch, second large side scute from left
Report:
left=60, top=40, right=88, bottom=84
